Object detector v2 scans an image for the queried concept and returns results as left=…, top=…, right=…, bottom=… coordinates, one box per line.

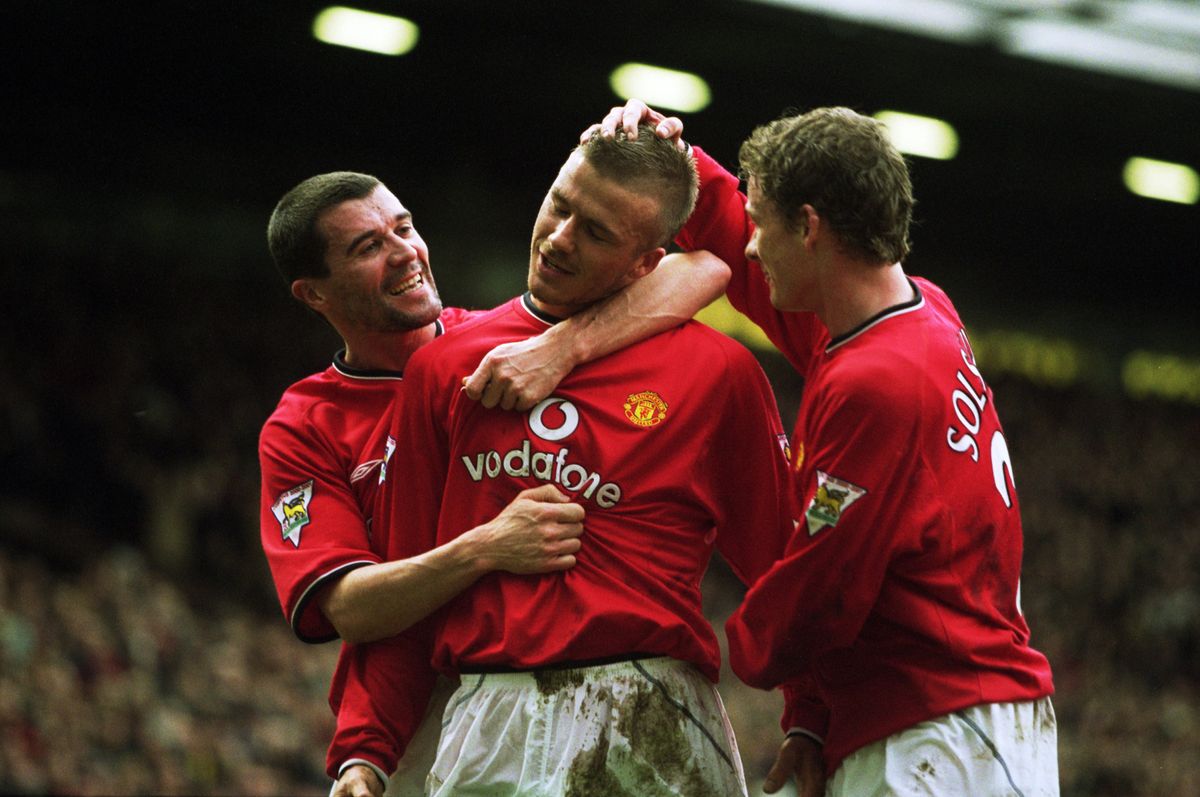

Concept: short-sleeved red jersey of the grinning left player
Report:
left=258, top=307, right=481, bottom=642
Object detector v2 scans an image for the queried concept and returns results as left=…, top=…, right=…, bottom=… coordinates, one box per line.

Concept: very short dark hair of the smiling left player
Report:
left=266, top=172, right=380, bottom=284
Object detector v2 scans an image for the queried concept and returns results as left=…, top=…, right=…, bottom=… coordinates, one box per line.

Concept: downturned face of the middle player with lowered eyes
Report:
left=529, top=151, right=666, bottom=318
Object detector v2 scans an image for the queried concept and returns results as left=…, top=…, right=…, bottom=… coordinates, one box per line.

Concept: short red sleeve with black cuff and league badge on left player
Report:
left=258, top=414, right=382, bottom=642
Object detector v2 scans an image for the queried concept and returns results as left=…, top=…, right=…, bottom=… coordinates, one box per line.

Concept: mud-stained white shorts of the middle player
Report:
left=426, top=658, right=746, bottom=797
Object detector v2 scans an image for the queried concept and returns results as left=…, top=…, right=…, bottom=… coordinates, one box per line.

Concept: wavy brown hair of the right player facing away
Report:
left=738, top=108, right=913, bottom=263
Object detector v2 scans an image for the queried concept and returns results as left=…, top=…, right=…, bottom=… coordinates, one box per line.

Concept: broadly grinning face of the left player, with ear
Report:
left=302, top=185, right=442, bottom=337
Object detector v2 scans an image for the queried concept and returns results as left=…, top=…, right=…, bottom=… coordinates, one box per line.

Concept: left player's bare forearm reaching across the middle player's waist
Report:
left=318, top=533, right=487, bottom=643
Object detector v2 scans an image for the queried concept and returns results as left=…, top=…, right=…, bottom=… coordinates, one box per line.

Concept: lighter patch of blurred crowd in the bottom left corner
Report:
left=0, top=547, right=336, bottom=795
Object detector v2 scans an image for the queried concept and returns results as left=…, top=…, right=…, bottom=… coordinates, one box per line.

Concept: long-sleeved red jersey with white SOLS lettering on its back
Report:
left=680, top=151, right=1054, bottom=772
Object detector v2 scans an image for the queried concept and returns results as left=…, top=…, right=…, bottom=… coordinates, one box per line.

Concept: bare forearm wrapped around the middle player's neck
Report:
left=542, top=252, right=730, bottom=365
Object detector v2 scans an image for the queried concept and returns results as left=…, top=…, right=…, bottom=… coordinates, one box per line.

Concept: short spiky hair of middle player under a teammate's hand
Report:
left=580, top=125, right=700, bottom=246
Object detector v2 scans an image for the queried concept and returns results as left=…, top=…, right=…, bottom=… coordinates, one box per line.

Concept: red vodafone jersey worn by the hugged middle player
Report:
left=330, top=298, right=791, bottom=769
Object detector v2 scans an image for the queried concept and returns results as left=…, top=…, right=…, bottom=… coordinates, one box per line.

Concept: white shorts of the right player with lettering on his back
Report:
left=826, top=697, right=1058, bottom=797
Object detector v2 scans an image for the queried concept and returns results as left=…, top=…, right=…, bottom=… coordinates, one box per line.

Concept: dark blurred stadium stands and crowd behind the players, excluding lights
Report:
left=0, top=0, right=1200, bottom=796
